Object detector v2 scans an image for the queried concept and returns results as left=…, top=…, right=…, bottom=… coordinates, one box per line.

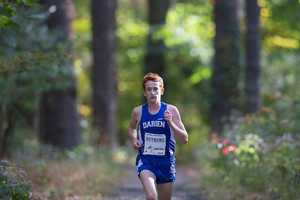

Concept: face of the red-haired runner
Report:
left=144, top=81, right=163, bottom=103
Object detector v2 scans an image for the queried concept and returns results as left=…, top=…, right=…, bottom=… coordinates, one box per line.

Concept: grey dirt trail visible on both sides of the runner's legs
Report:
left=104, top=166, right=205, bottom=200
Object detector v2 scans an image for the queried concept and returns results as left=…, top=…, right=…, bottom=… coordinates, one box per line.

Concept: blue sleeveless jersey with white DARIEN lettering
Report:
left=138, top=102, right=176, bottom=161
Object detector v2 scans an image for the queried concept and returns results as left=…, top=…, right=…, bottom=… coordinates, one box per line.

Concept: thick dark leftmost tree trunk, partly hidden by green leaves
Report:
left=39, top=0, right=81, bottom=149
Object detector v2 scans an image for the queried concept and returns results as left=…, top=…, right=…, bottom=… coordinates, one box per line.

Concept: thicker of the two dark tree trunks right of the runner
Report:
left=211, top=0, right=240, bottom=134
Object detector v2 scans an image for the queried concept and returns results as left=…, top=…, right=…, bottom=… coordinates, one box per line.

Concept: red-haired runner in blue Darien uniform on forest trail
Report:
left=128, top=73, right=188, bottom=200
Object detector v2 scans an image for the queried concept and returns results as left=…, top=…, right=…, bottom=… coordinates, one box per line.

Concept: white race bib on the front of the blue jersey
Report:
left=143, top=133, right=166, bottom=156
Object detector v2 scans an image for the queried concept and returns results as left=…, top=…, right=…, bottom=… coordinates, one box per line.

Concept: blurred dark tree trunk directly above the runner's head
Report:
left=145, top=0, right=170, bottom=78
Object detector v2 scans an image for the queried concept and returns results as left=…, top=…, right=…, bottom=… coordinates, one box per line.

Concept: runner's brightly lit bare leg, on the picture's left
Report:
left=140, top=170, right=157, bottom=200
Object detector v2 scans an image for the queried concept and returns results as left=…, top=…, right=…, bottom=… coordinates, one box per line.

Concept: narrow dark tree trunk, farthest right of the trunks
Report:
left=245, top=0, right=261, bottom=113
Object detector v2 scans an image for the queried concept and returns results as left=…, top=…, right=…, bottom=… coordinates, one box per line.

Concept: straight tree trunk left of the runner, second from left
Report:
left=91, top=0, right=117, bottom=146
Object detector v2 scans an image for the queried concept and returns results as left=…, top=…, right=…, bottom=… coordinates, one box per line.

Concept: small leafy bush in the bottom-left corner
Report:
left=0, top=160, right=31, bottom=200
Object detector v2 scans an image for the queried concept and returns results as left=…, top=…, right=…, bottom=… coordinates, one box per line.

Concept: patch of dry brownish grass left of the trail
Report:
left=26, top=160, right=118, bottom=199
